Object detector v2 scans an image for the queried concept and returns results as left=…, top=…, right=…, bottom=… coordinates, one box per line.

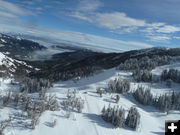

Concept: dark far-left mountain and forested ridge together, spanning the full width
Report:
left=0, top=34, right=180, bottom=81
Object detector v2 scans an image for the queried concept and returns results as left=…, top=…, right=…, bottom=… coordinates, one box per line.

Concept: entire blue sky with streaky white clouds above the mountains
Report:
left=0, top=0, right=180, bottom=50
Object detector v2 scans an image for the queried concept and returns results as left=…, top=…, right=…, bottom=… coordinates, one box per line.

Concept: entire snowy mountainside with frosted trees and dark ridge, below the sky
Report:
left=0, top=47, right=180, bottom=135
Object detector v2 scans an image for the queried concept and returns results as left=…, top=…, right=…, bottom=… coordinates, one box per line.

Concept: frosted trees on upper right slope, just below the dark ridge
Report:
left=117, top=55, right=172, bottom=82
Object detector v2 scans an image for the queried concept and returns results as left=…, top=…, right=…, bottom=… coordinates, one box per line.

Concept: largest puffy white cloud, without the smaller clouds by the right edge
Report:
left=68, top=11, right=147, bottom=34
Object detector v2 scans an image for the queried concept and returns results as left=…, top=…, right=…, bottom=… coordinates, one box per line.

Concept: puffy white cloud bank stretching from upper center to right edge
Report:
left=70, top=12, right=180, bottom=37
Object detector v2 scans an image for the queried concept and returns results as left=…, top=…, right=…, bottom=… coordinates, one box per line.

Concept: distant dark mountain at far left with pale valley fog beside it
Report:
left=0, top=33, right=91, bottom=60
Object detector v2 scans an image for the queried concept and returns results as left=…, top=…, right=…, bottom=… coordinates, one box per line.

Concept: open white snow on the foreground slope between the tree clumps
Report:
left=0, top=64, right=180, bottom=135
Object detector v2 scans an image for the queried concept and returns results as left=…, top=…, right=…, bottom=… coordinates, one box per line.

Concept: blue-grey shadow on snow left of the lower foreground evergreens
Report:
left=83, top=113, right=115, bottom=128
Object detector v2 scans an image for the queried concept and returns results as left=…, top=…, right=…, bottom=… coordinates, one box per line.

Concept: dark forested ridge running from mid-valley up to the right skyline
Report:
left=30, top=47, right=180, bottom=80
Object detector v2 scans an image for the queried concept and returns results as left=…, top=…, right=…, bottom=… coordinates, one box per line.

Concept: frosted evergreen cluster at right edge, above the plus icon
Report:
left=133, top=86, right=180, bottom=113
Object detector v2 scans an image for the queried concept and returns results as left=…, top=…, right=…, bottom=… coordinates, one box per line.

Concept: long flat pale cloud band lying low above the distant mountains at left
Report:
left=0, top=23, right=153, bottom=52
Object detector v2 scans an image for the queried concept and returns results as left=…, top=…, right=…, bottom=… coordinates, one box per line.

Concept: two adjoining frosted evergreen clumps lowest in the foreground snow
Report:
left=101, top=105, right=140, bottom=130
